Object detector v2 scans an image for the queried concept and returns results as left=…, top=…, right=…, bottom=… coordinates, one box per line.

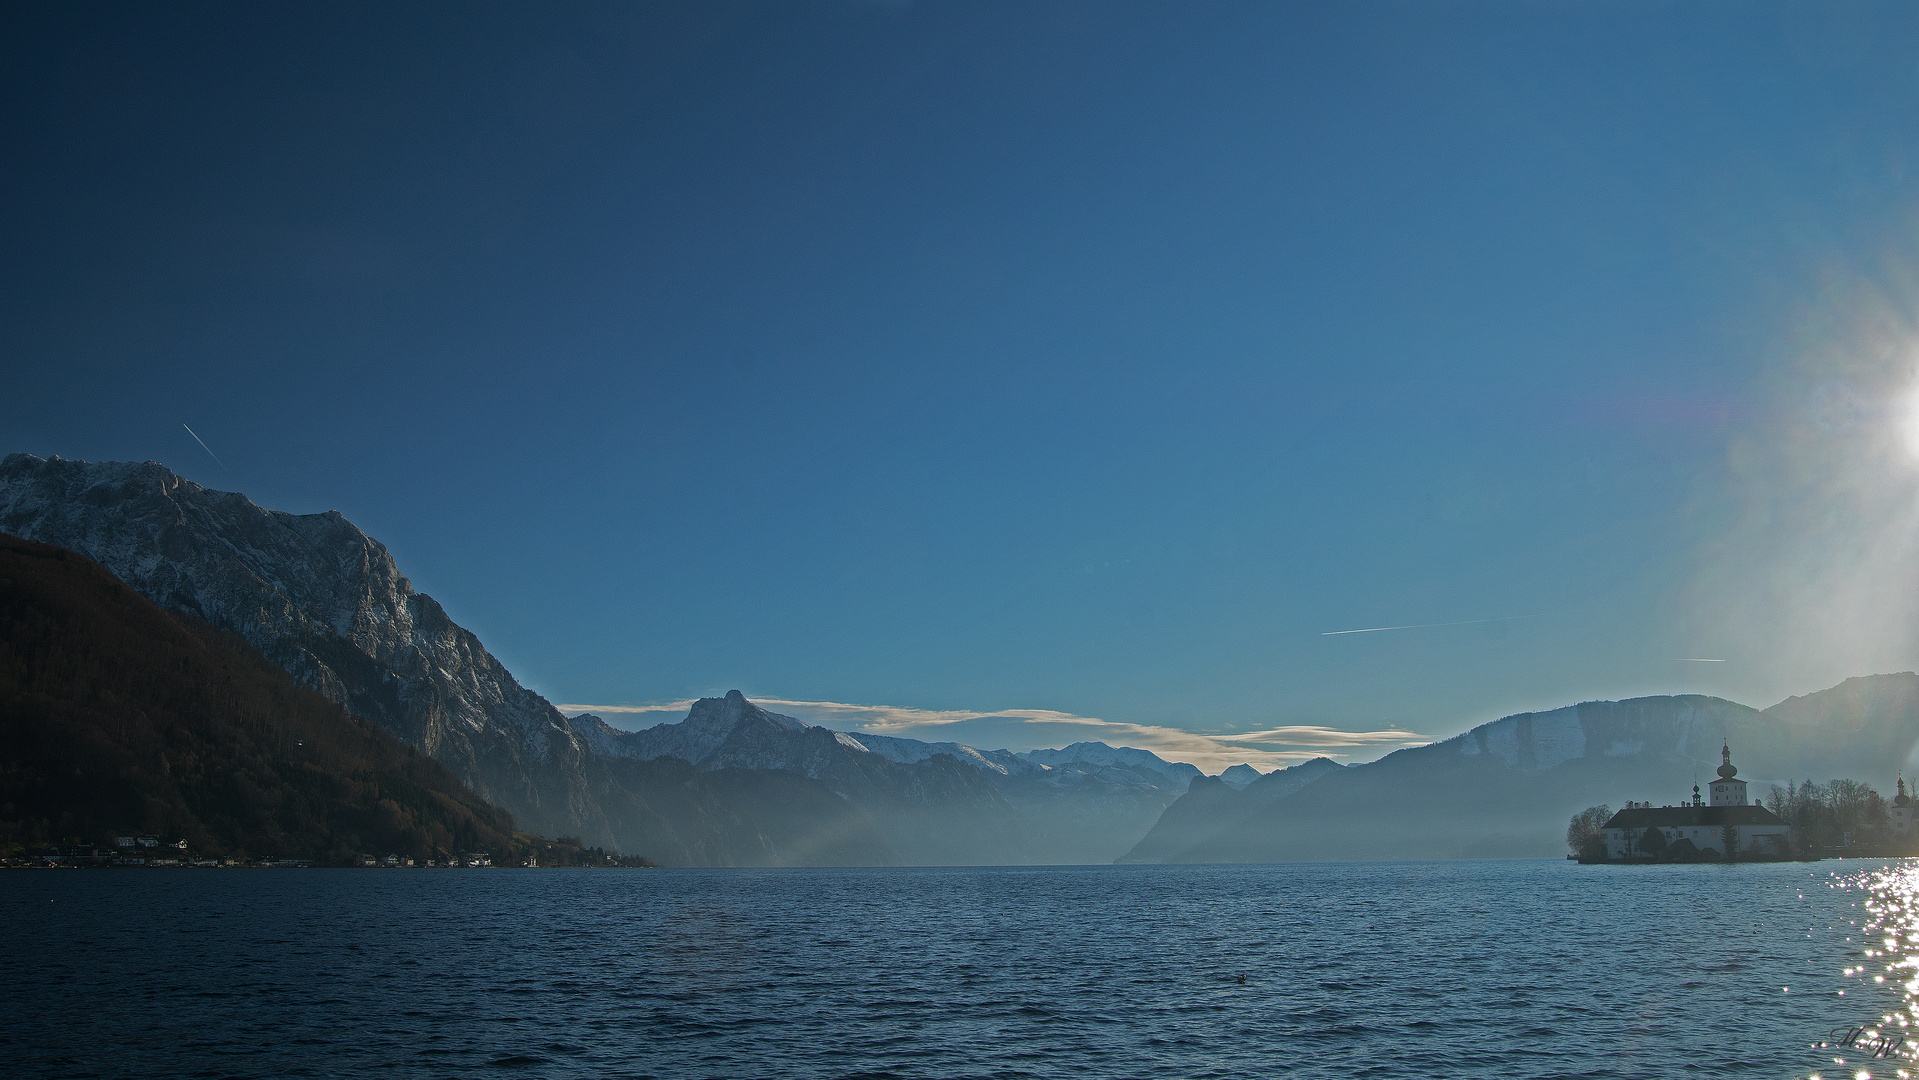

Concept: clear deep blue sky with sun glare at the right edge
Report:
left=0, top=0, right=1919, bottom=762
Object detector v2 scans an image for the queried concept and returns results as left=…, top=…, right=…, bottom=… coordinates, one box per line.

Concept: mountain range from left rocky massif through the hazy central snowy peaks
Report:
left=0, top=455, right=1199, bottom=865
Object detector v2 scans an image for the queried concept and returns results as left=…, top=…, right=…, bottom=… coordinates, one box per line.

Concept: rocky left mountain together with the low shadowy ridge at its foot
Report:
left=0, top=455, right=898, bottom=865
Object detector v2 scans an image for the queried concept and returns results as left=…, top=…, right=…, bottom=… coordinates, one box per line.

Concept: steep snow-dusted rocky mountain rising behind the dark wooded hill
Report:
left=0, top=455, right=618, bottom=846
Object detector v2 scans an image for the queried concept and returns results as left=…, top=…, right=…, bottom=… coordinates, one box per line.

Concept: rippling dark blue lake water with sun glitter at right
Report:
left=0, top=859, right=1919, bottom=1080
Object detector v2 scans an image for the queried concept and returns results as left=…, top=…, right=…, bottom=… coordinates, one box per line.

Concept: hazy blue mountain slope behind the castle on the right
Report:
left=1126, top=690, right=1919, bottom=861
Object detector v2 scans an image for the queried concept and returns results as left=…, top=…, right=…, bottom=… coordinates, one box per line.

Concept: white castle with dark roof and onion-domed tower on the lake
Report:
left=1600, top=746, right=1788, bottom=859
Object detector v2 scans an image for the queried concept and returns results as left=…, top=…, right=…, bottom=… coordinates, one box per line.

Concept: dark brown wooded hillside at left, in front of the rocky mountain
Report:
left=0, top=537, right=530, bottom=865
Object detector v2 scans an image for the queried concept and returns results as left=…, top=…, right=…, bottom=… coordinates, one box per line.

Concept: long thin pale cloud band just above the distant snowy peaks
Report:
left=558, top=698, right=1428, bottom=775
